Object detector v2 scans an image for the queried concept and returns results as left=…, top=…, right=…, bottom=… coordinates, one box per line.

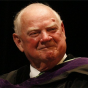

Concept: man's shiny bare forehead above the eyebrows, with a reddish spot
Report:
left=21, top=5, right=58, bottom=27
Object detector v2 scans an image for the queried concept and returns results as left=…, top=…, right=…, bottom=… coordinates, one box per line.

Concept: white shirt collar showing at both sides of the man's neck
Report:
left=29, top=54, right=67, bottom=78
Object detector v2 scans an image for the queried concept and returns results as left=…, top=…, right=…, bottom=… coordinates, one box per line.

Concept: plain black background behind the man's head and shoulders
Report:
left=0, top=0, right=88, bottom=75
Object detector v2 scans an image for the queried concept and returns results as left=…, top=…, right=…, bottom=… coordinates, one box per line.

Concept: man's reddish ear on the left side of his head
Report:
left=13, top=33, right=24, bottom=52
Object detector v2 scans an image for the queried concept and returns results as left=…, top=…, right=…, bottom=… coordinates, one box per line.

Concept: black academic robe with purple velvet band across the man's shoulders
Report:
left=1, top=55, right=88, bottom=88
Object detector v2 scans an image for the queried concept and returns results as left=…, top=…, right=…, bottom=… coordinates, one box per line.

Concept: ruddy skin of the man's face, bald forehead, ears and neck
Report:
left=13, top=4, right=66, bottom=71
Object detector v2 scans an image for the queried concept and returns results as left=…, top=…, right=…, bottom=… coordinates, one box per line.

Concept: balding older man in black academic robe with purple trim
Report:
left=1, top=3, right=88, bottom=88
